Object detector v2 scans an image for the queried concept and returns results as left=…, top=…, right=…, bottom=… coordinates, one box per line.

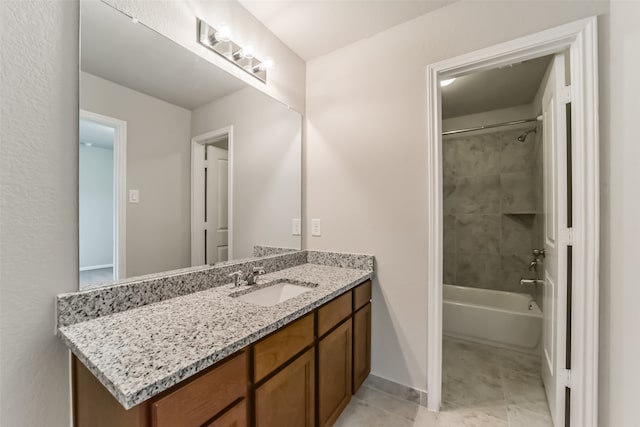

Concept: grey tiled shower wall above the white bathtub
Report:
left=442, top=127, right=542, bottom=293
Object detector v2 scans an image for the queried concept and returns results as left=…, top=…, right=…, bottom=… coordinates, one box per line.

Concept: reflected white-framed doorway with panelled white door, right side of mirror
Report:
left=191, top=126, right=233, bottom=266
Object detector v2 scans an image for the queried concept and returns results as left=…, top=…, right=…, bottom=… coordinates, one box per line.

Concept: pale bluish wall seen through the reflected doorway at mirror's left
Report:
left=78, top=144, right=114, bottom=268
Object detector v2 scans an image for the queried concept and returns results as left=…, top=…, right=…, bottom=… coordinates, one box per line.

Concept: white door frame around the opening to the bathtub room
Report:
left=426, top=16, right=600, bottom=427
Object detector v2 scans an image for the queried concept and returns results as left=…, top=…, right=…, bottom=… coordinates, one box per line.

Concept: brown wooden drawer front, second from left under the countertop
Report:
left=253, top=314, right=313, bottom=382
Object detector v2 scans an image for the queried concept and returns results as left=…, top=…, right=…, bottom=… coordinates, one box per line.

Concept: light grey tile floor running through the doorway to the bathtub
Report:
left=336, top=338, right=553, bottom=427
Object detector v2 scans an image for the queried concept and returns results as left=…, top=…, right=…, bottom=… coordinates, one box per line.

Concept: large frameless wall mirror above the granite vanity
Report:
left=79, top=1, right=301, bottom=288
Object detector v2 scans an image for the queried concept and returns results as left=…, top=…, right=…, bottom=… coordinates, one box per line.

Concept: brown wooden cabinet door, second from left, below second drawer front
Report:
left=255, top=349, right=315, bottom=427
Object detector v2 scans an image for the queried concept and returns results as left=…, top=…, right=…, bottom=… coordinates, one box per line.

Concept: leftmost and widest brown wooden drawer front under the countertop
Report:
left=151, top=352, right=249, bottom=427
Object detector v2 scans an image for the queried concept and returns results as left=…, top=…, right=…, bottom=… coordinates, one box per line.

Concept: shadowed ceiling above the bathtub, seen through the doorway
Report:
left=442, top=56, right=552, bottom=119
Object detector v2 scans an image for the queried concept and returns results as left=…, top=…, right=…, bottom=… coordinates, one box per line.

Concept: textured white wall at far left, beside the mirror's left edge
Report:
left=0, top=0, right=78, bottom=427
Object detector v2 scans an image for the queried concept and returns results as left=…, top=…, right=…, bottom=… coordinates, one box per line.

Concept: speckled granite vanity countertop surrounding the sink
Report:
left=58, top=264, right=373, bottom=409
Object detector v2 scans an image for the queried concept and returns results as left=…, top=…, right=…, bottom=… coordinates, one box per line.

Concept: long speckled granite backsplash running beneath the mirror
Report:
left=56, top=251, right=307, bottom=326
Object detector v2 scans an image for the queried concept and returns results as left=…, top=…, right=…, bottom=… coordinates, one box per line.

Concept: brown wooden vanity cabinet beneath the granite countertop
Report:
left=72, top=281, right=371, bottom=427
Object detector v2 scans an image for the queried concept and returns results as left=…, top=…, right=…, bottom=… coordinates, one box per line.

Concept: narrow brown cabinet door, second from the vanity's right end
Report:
left=318, top=319, right=352, bottom=427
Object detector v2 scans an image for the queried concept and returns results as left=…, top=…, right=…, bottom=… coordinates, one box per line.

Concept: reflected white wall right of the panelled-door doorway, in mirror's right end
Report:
left=191, top=87, right=302, bottom=258
